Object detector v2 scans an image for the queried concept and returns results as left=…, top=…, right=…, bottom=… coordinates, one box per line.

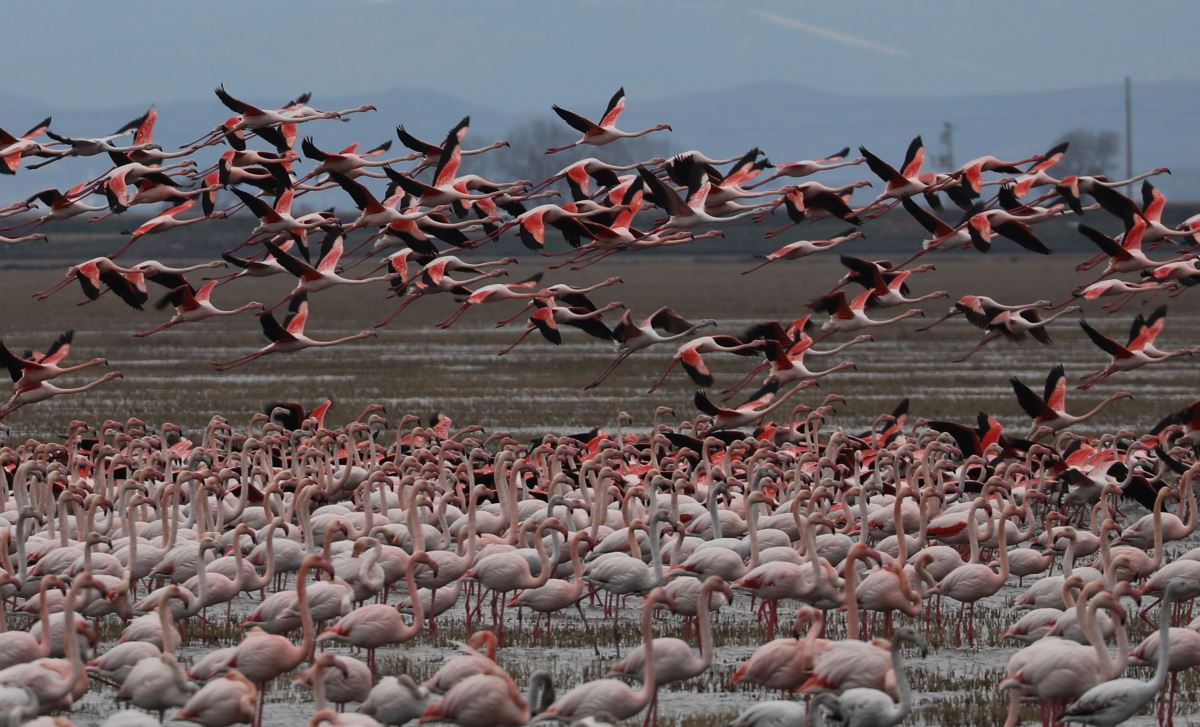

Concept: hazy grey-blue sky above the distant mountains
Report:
left=9, top=0, right=1200, bottom=110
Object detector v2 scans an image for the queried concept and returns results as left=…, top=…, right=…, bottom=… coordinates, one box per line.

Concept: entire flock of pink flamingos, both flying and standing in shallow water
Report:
left=0, top=88, right=1200, bottom=727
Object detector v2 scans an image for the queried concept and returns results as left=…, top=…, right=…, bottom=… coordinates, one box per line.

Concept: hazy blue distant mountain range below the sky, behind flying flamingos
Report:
left=0, top=82, right=1200, bottom=202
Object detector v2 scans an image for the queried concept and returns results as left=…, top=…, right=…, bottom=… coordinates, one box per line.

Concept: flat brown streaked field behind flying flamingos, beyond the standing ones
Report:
left=0, top=253, right=1200, bottom=435
